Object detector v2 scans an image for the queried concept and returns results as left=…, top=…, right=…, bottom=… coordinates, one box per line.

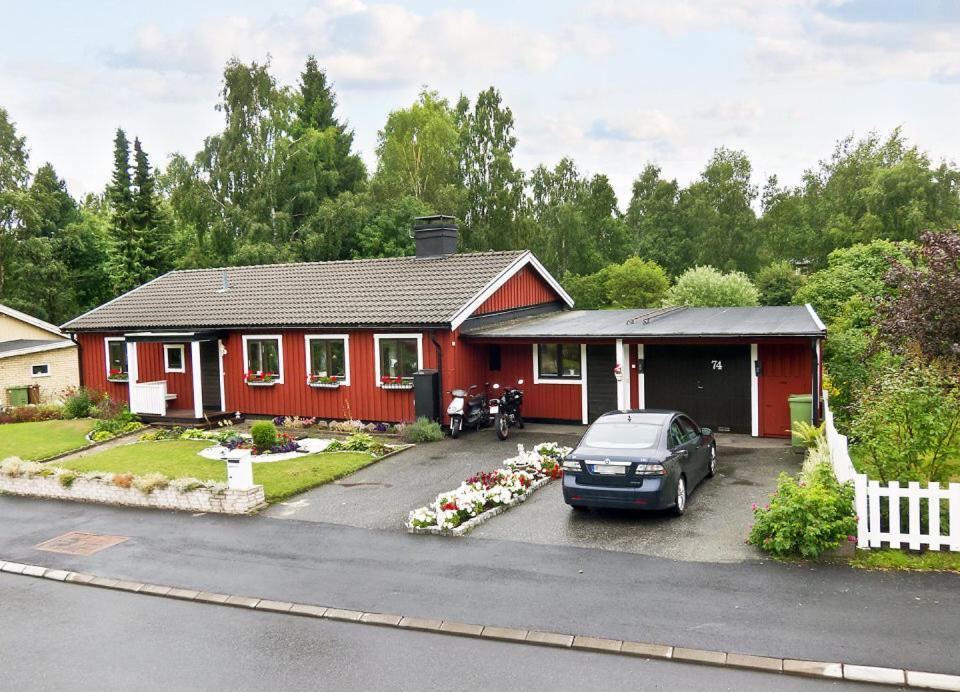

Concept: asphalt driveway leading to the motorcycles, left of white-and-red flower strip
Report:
left=265, top=424, right=583, bottom=531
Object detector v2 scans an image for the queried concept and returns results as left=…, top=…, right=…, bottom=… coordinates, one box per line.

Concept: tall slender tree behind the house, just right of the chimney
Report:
left=456, top=87, right=523, bottom=250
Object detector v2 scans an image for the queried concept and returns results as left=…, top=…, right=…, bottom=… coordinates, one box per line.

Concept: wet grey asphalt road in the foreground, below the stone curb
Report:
left=0, top=574, right=865, bottom=692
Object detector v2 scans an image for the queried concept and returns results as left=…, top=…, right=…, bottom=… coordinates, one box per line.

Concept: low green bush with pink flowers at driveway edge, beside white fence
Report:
left=747, top=463, right=857, bottom=559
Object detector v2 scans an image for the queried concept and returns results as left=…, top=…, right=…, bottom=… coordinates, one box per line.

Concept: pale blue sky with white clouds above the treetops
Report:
left=0, top=0, right=960, bottom=205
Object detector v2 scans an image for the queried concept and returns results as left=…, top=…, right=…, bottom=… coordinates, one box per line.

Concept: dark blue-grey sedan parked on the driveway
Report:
left=563, top=409, right=717, bottom=515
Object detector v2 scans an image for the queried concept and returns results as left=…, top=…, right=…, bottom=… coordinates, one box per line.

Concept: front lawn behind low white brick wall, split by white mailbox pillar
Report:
left=58, top=440, right=376, bottom=502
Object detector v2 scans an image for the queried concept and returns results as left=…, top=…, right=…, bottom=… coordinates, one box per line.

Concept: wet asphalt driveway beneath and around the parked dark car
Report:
left=470, top=435, right=803, bottom=562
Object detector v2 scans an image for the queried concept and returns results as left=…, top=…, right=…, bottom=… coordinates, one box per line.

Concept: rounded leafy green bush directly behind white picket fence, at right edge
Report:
left=850, top=359, right=960, bottom=482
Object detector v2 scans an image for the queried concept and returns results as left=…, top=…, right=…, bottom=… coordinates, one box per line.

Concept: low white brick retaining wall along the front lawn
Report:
left=0, top=474, right=264, bottom=514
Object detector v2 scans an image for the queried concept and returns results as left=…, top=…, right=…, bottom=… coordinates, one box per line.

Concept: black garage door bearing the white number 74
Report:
left=643, top=345, right=751, bottom=434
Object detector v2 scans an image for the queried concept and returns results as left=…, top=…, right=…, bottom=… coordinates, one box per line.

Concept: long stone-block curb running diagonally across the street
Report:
left=0, top=560, right=960, bottom=691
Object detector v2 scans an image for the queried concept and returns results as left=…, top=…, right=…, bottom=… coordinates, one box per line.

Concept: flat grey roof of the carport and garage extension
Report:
left=463, top=305, right=827, bottom=339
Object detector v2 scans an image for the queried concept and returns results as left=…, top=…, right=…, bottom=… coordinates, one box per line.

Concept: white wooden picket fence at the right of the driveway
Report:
left=823, top=392, right=960, bottom=552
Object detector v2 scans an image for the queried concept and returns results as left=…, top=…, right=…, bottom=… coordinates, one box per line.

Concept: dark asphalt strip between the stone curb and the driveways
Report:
left=0, top=497, right=960, bottom=674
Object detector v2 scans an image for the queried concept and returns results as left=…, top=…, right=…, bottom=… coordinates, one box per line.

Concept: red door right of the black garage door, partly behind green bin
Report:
left=757, top=344, right=811, bottom=437
